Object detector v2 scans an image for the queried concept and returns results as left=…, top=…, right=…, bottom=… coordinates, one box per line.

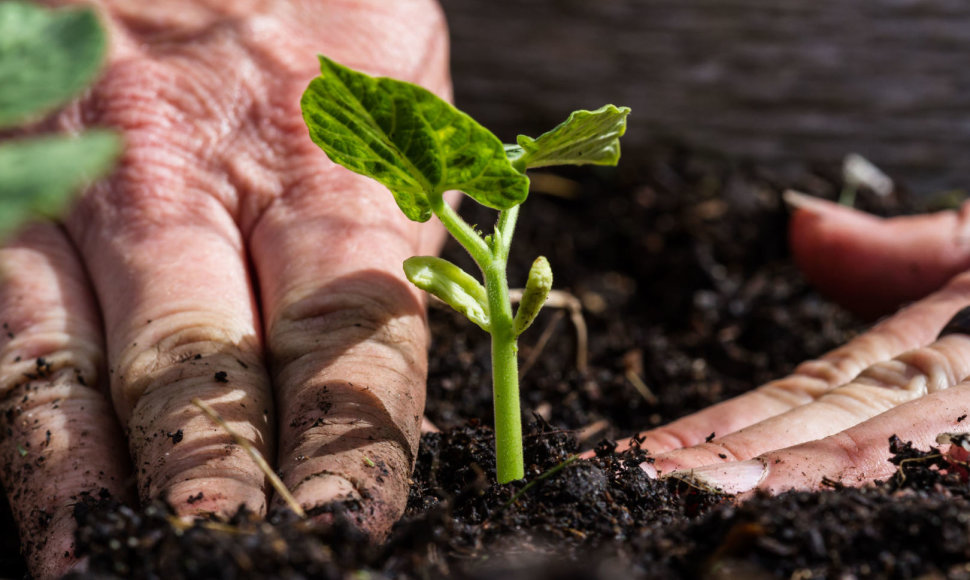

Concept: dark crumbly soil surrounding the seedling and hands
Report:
left=7, top=150, right=970, bottom=578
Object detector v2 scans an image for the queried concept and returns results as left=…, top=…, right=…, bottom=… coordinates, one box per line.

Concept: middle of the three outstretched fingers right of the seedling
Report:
left=652, top=334, right=970, bottom=473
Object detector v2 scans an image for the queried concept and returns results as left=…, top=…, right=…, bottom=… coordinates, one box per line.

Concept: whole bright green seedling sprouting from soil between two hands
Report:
left=301, top=56, right=630, bottom=483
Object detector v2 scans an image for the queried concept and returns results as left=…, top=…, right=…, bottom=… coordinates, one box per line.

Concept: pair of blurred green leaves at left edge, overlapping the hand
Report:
left=0, top=1, right=121, bottom=236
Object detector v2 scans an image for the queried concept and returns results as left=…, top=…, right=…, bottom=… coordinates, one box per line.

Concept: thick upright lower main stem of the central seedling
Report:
left=485, top=258, right=525, bottom=483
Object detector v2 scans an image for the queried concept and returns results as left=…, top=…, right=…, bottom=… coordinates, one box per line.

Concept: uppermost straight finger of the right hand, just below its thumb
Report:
left=604, top=274, right=970, bottom=454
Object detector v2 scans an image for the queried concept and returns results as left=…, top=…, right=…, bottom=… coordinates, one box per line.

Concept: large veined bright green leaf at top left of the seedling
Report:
left=300, top=56, right=529, bottom=222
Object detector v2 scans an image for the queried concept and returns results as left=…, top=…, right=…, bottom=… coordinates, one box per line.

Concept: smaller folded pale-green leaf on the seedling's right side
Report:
left=505, top=105, right=630, bottom=170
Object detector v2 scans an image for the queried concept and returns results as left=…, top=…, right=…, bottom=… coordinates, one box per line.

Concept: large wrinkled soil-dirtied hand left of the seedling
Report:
left=0, top=0, right=449, bottom=577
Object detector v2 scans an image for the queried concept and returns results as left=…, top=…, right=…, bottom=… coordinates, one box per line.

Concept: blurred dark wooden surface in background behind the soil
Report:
left=441, top=0, right=970, bottom=192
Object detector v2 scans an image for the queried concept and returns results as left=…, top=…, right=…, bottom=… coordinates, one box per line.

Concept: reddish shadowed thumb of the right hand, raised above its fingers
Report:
left=785, top=191, right=970, bottom=318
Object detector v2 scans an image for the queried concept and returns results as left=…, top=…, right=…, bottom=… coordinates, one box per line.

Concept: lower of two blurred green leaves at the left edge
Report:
left=0, top=131, right=121, bottom=236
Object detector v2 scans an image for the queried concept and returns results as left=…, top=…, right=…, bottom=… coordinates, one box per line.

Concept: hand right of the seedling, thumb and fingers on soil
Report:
left=612, top=197, right=970, bottom=497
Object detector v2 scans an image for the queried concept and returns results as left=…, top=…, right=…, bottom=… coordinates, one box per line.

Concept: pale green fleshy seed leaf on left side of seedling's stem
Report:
left=404, top=256, right=490, bottom=332
